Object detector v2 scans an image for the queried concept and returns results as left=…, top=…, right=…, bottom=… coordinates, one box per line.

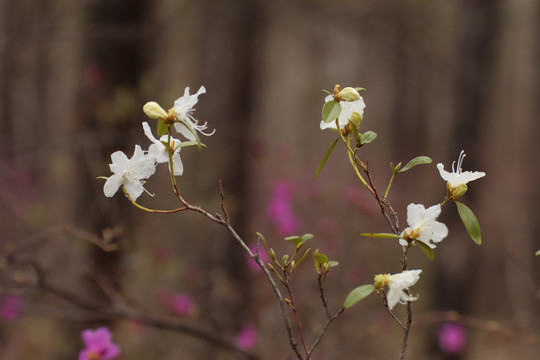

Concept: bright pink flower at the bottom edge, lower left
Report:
left=79, top=327, right=120, bottom=360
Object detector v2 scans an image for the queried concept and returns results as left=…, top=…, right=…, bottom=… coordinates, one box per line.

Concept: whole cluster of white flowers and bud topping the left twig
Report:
left=103, top=86, right=214, bottom=200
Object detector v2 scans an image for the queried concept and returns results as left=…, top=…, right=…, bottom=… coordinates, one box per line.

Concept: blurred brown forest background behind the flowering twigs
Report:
left=0, top=0, right=540, bottom=360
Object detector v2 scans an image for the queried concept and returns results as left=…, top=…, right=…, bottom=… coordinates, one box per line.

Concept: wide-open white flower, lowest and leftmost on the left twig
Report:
left=103, top=145, right=156, bottom=200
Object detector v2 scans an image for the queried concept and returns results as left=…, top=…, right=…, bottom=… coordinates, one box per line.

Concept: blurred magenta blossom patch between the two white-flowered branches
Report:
left=267, top=181, right=299, bottom=236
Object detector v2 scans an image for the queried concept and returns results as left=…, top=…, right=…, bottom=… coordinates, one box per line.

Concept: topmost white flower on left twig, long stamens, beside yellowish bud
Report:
left=172, top=86, right=214, bottom=141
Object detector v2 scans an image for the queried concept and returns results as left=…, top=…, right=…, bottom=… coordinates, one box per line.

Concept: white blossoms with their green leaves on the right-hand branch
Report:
left=316, top=85, right=485, bottom=310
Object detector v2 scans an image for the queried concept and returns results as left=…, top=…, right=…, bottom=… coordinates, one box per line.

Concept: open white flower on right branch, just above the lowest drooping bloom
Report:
left=399, top=204, right=448, bottom=249
